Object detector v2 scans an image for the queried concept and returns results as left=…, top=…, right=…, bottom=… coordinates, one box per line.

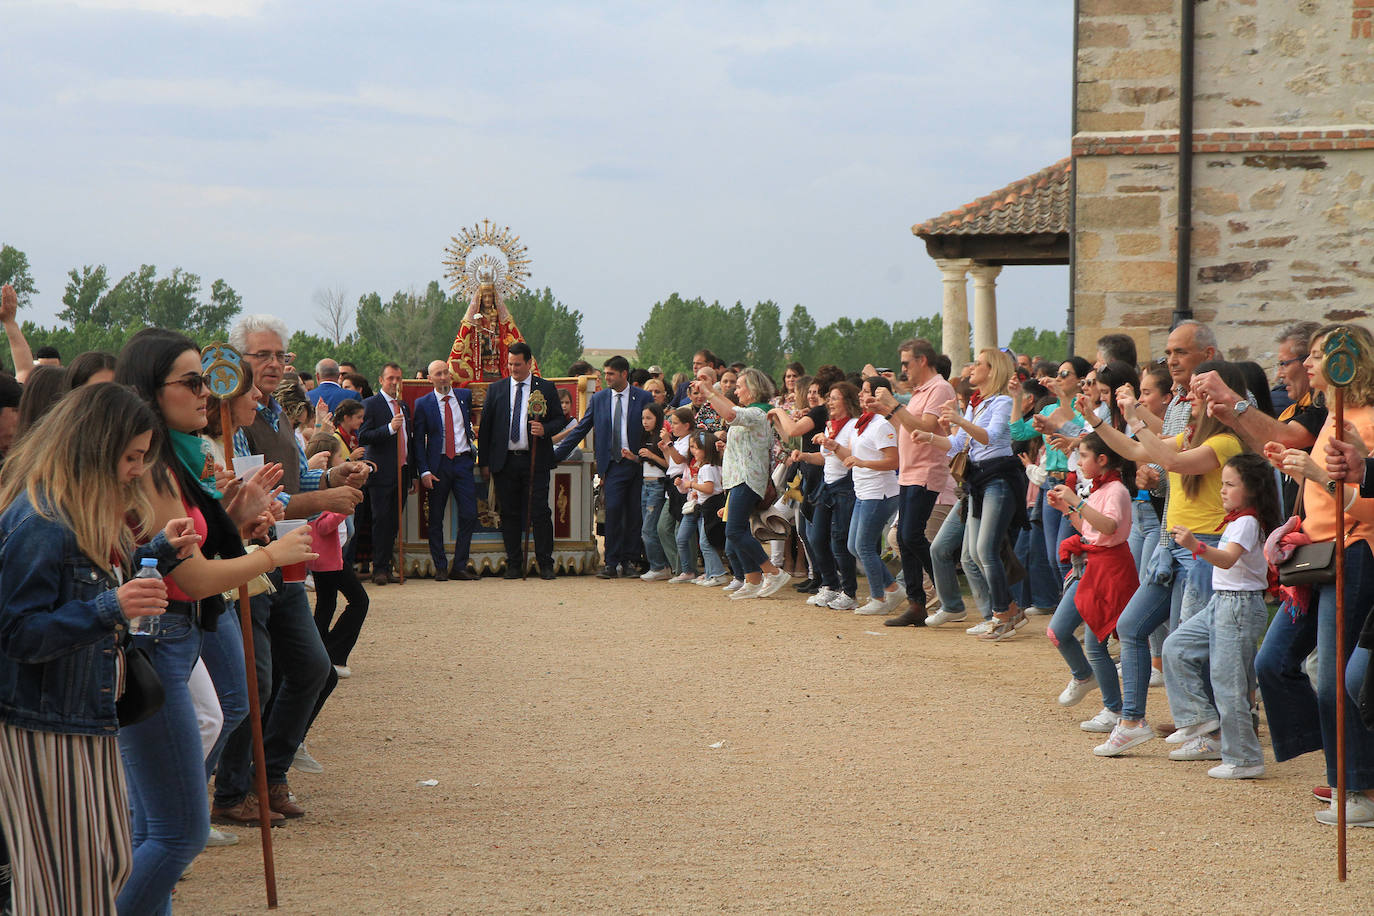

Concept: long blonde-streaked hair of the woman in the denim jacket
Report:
left=0, top=382, right=158, bottom=573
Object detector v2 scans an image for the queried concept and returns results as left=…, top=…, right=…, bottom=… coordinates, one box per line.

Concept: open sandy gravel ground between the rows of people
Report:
left=176, top=577, right=1374, bottom=913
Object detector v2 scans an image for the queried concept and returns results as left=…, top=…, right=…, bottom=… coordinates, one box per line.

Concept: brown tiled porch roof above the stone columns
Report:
left=911, top=158, right=1073, bottom=236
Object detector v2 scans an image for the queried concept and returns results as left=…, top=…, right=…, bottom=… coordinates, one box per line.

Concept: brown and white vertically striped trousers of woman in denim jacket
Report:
left=0, top=722, right=133, bottom=916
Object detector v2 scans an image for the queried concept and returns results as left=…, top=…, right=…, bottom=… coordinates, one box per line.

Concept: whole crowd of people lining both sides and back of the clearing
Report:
left=0, top=265, right=1374, bottom=913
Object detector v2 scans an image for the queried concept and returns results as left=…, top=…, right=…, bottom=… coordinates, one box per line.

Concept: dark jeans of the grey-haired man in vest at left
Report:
left=214, top=585, right=334, bottom=808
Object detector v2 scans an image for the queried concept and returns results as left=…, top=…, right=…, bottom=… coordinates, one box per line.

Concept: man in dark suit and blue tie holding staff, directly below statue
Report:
left=477, top=342, right=567, bottom=580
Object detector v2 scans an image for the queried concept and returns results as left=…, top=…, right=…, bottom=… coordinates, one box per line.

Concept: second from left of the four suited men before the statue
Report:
left=415, top=360, right=477, bottom=582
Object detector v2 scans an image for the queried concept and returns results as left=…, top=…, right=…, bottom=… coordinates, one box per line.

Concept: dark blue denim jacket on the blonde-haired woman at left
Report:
left=0, top=497, right=176, bottom=735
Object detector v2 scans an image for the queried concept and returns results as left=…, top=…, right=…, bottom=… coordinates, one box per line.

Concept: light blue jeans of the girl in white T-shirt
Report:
left=1164, top=591, right=1268, bottom=766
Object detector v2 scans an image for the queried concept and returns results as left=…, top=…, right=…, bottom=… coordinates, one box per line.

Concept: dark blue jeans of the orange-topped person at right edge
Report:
left=1257, top=541, right=1374, bottom=791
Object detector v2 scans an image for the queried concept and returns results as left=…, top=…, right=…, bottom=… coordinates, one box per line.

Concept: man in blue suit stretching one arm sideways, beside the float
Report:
left=554, top=356, right=654, bottom=578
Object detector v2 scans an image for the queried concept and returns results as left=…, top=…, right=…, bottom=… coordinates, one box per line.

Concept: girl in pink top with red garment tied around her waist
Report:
left=1046, top=433, right=1139, bottom=733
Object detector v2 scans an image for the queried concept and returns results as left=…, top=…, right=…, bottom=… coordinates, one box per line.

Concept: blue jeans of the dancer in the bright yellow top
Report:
left=1117, top=534, right=1220, bottom=721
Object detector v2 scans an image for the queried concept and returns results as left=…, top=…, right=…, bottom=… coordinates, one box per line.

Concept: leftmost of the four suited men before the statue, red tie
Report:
left=357, top=363, right=415, bottom=585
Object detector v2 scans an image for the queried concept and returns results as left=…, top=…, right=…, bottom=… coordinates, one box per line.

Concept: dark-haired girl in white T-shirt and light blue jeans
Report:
left=1164, top=452, right=1282, bottom=779
